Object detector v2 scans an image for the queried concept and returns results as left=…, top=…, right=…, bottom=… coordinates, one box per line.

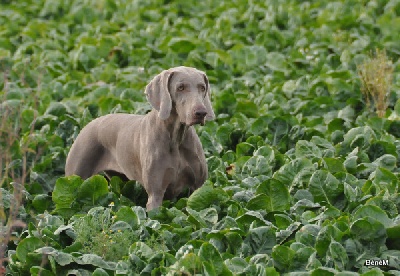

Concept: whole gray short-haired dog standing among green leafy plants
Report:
left=65, top=66, right=215, bottom=210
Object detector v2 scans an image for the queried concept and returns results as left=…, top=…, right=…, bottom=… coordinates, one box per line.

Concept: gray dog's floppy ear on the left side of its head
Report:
left=144, top=70, right=173, bottom=120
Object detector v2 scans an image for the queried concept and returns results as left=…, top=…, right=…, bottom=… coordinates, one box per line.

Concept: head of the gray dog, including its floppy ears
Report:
left=145, top=66, right=215, bottom=126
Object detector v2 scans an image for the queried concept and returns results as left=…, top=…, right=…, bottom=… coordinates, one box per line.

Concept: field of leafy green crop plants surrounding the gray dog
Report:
left=0, top=0, right=400, bottom=276
